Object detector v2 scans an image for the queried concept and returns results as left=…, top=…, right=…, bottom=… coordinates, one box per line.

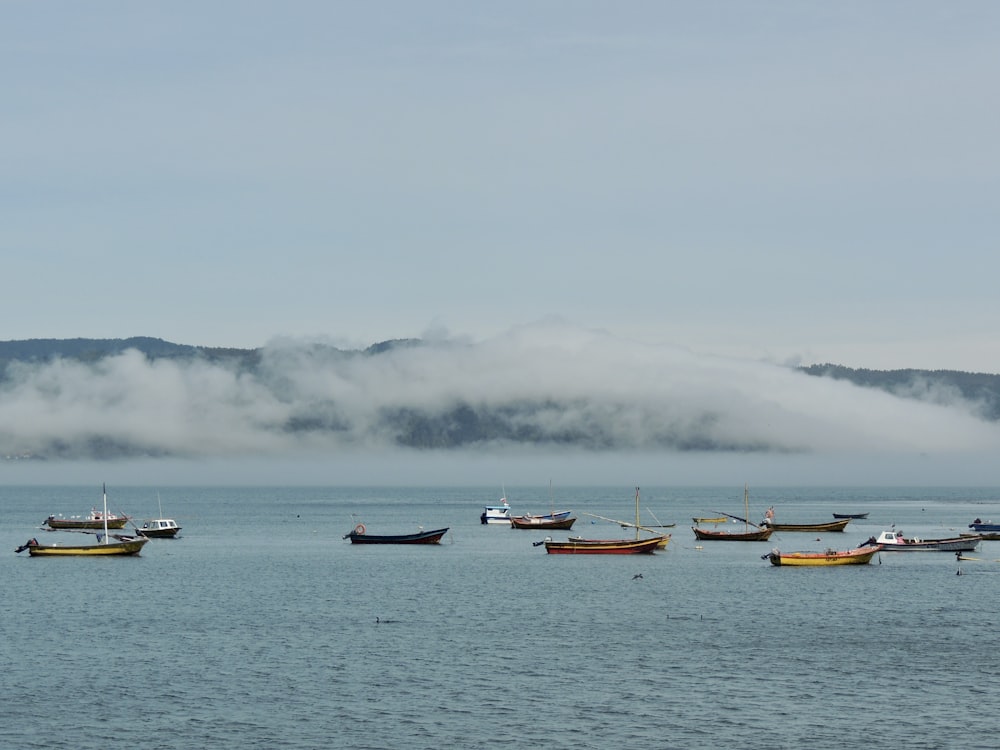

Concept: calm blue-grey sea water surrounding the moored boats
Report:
left=0, top=487, right=1000, bottom=750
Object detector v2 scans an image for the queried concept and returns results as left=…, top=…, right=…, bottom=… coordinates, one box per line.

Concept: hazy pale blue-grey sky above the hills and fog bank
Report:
left=0, top=0, right=1000, bottom=372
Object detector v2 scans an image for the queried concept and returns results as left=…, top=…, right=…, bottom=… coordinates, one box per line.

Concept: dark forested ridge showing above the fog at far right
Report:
left=799, top=364, right=1000, bottom=420
